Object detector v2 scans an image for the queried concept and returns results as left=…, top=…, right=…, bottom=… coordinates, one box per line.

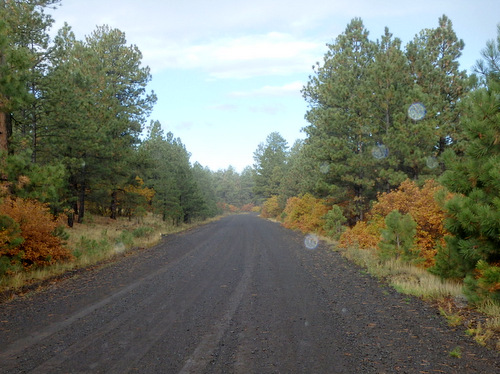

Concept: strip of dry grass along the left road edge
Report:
left=0, top=214, right=220, bottom=292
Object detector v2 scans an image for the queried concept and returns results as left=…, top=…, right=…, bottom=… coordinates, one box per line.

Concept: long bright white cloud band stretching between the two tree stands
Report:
left=141, top=32, right=324, bottom=79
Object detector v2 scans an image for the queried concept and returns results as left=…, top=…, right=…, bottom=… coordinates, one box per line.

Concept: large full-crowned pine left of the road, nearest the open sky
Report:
left=44, top=25, right=156, bottom=220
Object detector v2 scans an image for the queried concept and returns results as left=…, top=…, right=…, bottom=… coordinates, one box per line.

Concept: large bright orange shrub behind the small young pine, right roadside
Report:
left=370, top=180, right=446, bottom=267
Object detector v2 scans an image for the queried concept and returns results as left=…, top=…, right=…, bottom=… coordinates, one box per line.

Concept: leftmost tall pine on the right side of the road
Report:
left=302, top=18, right=378, bottom=219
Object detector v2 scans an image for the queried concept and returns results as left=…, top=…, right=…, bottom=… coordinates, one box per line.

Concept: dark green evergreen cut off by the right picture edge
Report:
left=436, top=26, right=500, bottom=297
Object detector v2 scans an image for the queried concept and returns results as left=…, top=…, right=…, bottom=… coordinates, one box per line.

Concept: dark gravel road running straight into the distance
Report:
left=0, top=215, right=500, bottom=374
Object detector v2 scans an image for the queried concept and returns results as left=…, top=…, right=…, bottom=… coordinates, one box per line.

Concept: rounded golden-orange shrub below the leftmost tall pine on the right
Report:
left=283, top=193, right=328, bottom=233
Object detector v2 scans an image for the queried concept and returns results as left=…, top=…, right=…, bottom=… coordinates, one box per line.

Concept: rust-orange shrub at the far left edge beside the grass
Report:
left=0, top=198, right=72, bottom=267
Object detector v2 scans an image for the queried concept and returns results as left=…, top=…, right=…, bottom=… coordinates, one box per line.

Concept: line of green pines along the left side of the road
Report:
left=0, top=0, right=253, bottom=231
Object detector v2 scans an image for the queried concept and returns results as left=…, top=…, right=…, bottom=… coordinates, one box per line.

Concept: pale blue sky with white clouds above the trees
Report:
left=50, top=0, right=500, bottom=172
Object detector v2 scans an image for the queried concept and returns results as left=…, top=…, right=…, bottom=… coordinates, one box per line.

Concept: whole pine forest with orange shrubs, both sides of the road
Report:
left=0, top=0, right=500, bottom=316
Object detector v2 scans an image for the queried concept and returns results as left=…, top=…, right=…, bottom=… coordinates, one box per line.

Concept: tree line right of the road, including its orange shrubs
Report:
left=254, top=16, right=500, bottom=302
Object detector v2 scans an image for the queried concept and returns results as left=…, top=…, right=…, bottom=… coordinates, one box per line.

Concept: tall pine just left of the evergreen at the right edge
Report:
left=406, top=15, right=470, bottom=167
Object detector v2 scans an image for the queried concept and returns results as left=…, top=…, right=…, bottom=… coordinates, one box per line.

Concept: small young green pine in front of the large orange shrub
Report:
left=379, top=210, right=418, bottom=261
